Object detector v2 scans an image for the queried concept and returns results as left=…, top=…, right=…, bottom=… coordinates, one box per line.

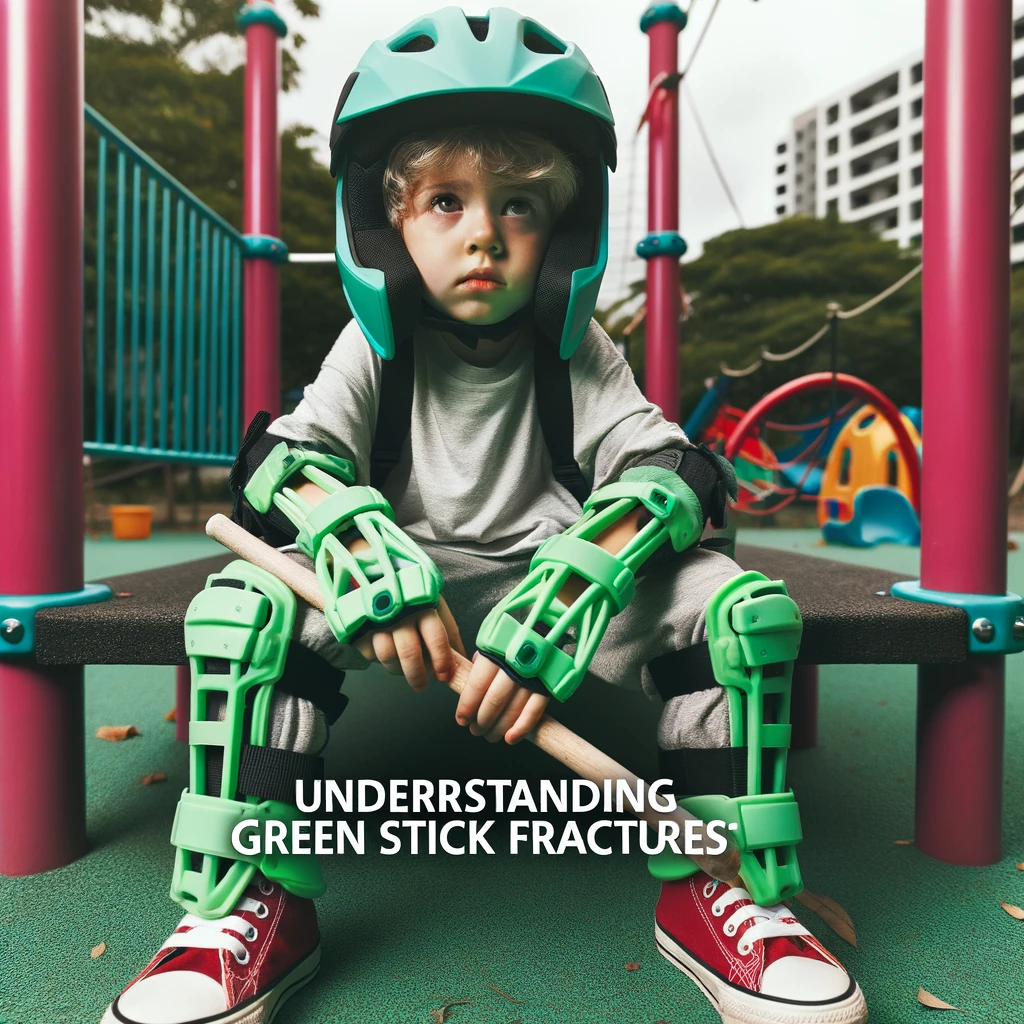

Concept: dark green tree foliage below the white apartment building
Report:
left=601, top=217, right=921, bottom=420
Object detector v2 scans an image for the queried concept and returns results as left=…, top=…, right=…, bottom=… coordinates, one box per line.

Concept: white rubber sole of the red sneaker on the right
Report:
left=654, top=923, right=867, bottom=1024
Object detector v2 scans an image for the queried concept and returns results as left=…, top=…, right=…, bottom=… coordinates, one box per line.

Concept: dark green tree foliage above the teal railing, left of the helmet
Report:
left=85, top=0, right=350, bottom=399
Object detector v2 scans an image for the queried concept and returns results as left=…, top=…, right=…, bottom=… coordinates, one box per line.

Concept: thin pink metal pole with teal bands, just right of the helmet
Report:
left=637, top=4, right=686, bottom=423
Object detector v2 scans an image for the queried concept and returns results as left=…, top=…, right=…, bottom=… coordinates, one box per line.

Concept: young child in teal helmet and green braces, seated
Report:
left=103, top=7, right=866, bottom=1024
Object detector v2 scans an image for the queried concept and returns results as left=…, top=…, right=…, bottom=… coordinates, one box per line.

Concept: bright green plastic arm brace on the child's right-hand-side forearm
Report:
left=476, top=466, right=703, bottom=700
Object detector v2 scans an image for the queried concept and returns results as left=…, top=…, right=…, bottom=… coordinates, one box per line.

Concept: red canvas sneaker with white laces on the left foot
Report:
left=101, top=874, right=321, bottom=1024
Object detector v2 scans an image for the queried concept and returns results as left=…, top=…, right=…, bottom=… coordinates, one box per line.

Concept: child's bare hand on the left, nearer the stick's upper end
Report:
left=353, top=597, right=466, bottom=693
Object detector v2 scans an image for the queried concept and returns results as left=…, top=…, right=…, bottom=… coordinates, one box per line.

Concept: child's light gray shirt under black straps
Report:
left=269, top=321, right=686, bottom=558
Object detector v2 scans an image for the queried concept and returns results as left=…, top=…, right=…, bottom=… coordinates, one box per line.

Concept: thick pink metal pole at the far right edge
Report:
left=915, top=0, right=1012, bottom=865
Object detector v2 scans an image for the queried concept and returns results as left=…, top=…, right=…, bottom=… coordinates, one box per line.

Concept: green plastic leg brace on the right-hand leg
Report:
left=649, top=572, right=804, bottom=906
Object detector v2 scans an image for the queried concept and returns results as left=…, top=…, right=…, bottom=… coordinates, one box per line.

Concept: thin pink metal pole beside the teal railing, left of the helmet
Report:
left=242, top=0, right=283, bottom=430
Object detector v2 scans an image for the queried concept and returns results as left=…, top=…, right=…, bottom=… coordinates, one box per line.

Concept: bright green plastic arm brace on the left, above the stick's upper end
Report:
left=245, top=442, right=443, bottom=643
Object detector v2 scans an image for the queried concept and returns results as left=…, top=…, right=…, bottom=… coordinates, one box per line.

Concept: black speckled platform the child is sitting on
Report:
left=36, top=544, right=967, bottom=665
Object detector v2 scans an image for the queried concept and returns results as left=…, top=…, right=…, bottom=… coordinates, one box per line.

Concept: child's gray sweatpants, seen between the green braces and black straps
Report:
left=269, top=543, right=742, bottom=752
